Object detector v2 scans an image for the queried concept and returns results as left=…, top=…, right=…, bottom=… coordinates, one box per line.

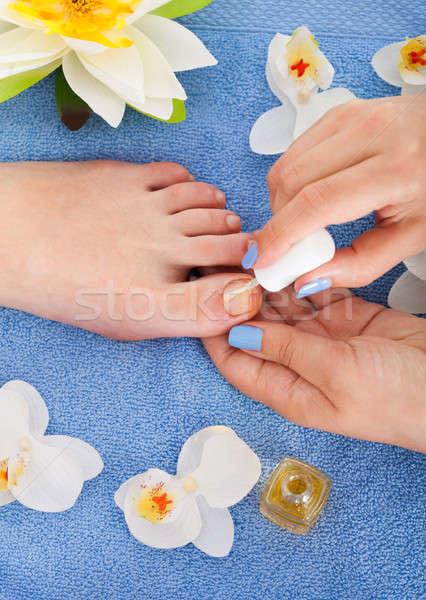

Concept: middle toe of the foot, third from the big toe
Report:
left=173, top=208, right=241, bottom=236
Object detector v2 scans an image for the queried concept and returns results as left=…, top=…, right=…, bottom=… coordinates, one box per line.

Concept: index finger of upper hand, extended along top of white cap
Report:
left=251, top=156, right=409, bottom=268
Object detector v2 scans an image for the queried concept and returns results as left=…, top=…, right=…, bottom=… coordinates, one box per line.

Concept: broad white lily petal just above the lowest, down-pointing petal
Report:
left=79, top=38, right=144, bottom=104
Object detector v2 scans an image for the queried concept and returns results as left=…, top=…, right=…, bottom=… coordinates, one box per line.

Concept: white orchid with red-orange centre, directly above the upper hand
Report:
left=250, top=27, right=355, bottom=154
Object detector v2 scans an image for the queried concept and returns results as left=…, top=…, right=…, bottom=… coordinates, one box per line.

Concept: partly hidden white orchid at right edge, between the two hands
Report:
left=388, top=250, right=426, bottom=314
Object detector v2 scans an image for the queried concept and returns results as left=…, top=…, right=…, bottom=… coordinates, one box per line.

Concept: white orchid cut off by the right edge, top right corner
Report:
left=371, top=35, right=426, bottom=96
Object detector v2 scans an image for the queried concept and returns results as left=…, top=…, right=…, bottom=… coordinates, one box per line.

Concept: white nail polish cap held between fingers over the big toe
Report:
left=254, top=229, right=336, bottom=292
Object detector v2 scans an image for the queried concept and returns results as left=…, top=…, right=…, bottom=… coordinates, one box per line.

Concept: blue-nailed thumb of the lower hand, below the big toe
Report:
left=229, top=321, right=347, bottom=390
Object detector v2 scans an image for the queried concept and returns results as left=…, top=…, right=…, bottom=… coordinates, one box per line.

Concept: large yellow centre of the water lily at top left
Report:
left=8, top=0, right=143, bottom=48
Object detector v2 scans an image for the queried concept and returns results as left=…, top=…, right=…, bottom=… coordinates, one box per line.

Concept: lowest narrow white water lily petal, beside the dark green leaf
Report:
left=62, top=52, right=126, bottom=127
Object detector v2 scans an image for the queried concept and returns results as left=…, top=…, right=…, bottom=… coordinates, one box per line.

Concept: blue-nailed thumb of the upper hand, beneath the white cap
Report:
left=295, top=221, right=426, bottom=290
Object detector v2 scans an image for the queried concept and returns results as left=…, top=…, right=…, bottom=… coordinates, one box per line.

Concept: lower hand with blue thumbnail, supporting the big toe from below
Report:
left=204, top=289, right=426, bottom=452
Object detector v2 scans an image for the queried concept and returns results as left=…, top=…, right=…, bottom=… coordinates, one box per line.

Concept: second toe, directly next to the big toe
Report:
left=183, top=233, right=252, bottom=267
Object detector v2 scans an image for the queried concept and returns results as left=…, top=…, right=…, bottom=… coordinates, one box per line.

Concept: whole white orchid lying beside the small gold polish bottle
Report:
left=115, top=426, right=261, bottom=557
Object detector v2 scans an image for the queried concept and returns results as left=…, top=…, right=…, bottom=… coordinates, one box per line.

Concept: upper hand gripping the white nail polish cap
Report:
left=252, top=95, right=426, bottom=295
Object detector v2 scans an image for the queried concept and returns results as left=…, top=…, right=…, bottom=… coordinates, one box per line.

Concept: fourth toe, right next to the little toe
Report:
left=158, top=181, right=226, bottom=214
